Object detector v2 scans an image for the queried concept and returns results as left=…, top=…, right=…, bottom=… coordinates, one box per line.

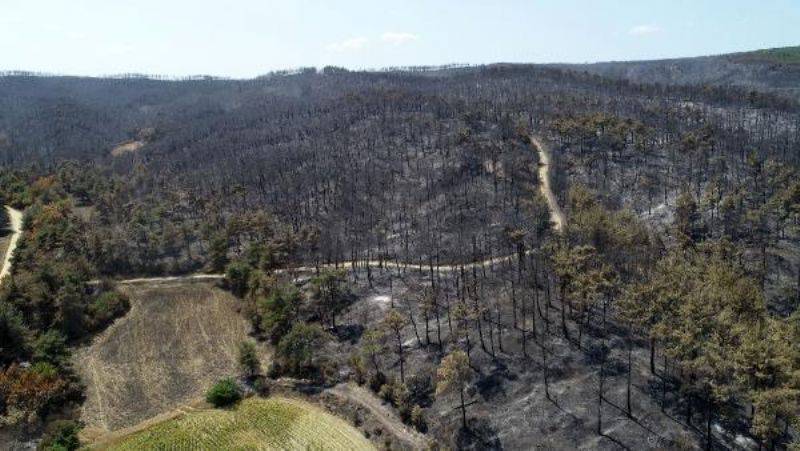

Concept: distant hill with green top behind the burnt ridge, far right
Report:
left=557, top=46, right=800, bottom=97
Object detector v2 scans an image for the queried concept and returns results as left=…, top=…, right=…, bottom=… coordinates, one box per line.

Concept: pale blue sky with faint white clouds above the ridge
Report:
left=0, top=0, right=800, bottom=77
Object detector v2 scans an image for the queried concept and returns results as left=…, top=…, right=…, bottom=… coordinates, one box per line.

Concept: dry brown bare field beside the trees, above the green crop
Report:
left=74, top=281, right=266, bottom=438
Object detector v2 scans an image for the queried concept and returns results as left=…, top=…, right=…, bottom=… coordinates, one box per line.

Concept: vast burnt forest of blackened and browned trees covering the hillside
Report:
left=0, top=51, right=800, bottom=449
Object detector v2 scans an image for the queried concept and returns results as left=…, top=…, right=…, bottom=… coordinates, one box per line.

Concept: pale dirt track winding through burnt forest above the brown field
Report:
left=101, top=135, right=566, bottom=285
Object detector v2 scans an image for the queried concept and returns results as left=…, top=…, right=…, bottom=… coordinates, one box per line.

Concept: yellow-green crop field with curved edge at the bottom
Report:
left=107, top=398, right=374, bottom=450
